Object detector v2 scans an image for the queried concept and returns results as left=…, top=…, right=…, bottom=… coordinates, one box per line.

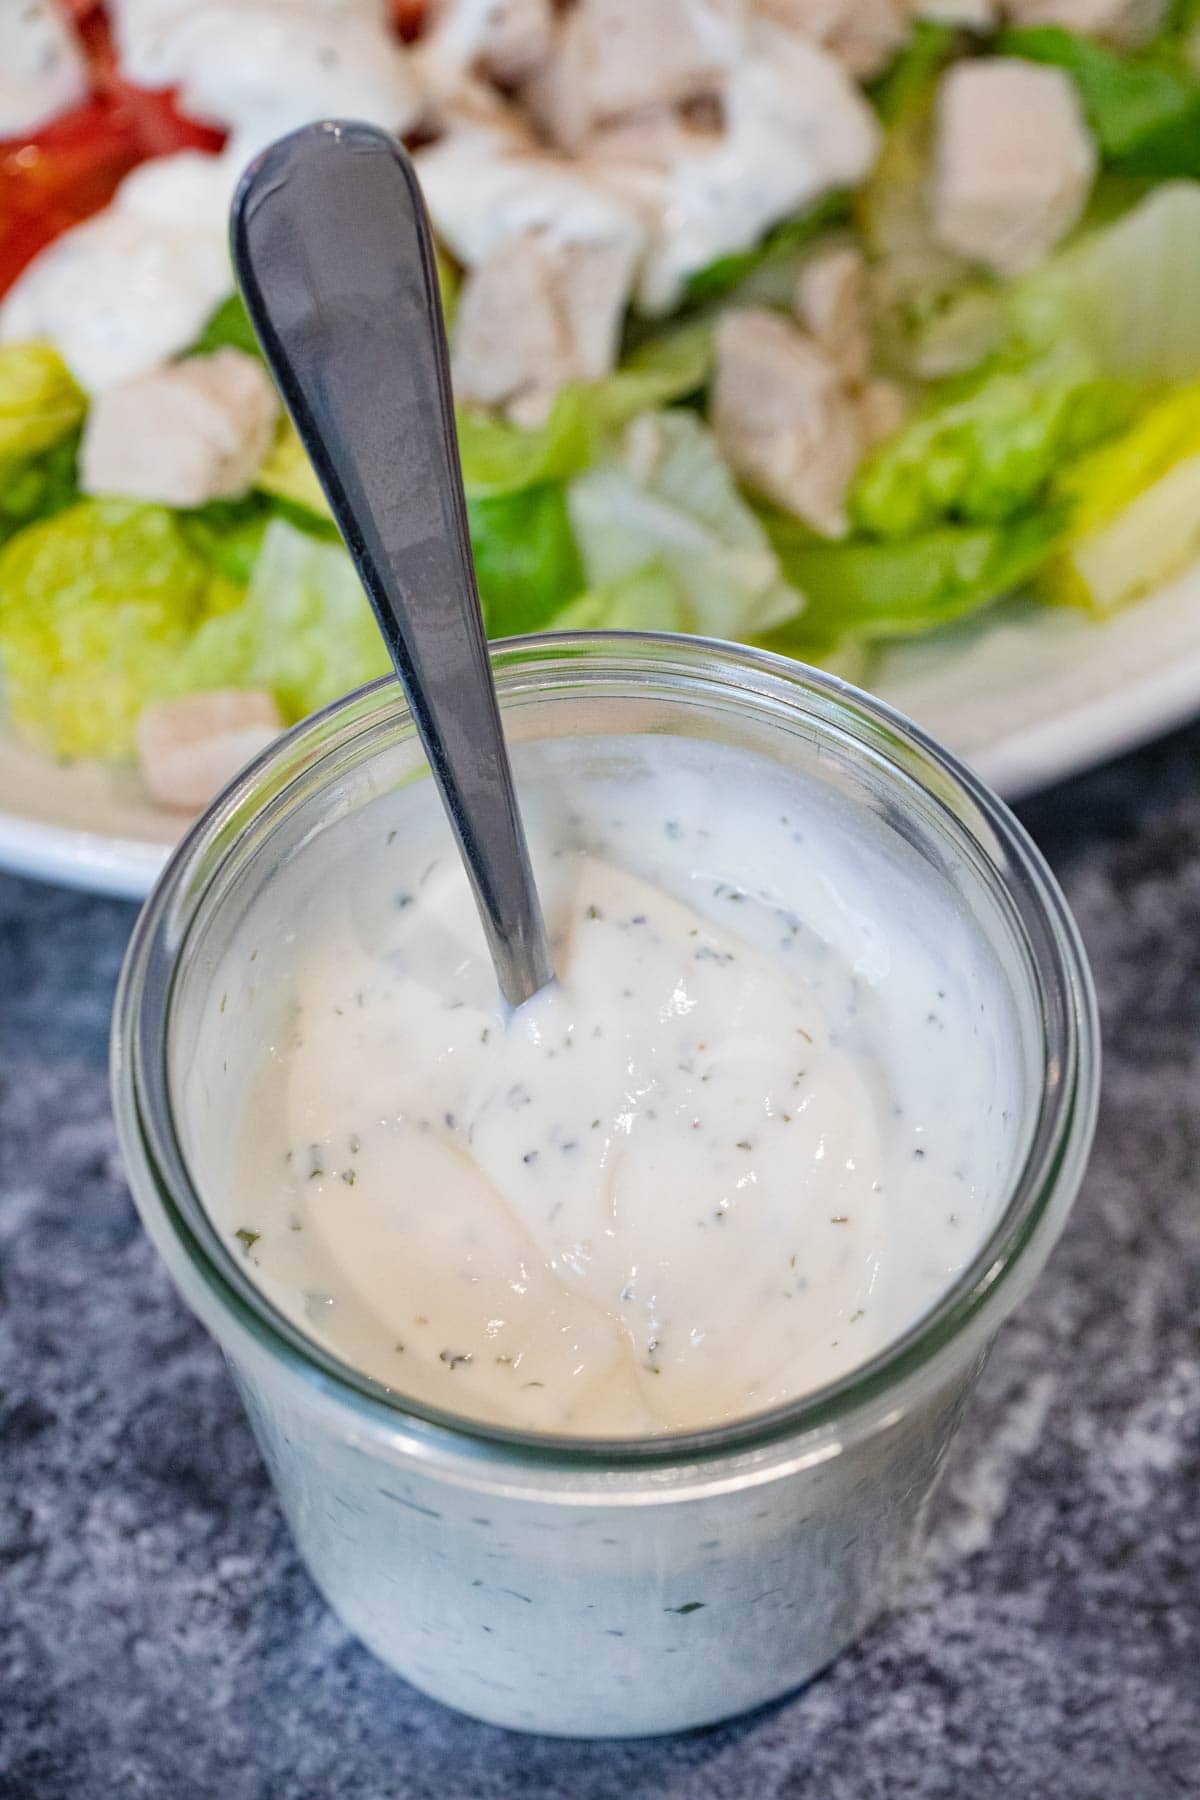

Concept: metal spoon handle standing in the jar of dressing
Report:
left=232, top=121, right=554, bottom=1006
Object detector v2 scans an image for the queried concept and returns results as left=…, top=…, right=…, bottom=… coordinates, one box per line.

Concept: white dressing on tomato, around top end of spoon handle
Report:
left=0, top=0, right=416, bottom=392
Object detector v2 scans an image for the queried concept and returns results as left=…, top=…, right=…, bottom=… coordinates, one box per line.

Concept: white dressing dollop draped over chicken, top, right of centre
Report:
left=585, top=20, right=880, bottom=313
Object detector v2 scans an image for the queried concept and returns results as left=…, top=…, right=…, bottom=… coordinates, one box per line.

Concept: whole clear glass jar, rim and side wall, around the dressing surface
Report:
left=113, top=634, right=1097, bottom=1735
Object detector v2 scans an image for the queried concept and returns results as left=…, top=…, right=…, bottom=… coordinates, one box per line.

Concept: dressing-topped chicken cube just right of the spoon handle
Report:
left=453, top=232, right=635, bottom=425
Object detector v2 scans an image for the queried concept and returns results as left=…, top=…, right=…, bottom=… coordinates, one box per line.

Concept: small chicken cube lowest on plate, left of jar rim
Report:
left=137, top=688, right=284, bottom=812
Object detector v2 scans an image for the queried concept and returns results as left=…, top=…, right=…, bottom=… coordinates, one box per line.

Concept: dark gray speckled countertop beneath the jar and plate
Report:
left=0, top=729, right=1200, bottom=1800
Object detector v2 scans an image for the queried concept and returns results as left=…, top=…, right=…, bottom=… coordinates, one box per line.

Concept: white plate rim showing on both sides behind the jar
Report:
left=0, top=565, right=1200, bottom=898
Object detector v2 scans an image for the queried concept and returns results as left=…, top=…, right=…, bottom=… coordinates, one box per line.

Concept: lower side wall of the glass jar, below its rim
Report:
left=234, top=1364, right=975, bottom=1737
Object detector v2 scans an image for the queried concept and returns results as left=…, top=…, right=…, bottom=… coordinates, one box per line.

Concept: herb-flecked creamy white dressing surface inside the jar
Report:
left=201, top=738, right=1025, bottom=1435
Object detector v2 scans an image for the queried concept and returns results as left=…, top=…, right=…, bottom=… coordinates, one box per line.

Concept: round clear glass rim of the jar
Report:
left=112, top=632, right=1099, bottom=1472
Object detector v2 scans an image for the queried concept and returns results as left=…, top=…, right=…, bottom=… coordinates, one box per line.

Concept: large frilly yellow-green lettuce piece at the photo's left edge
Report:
left=0, top=500, right=214, bottom=758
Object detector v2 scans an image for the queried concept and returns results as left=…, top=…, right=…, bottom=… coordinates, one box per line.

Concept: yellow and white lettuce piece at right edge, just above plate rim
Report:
left=1038, top=382, right=1200, bottom=614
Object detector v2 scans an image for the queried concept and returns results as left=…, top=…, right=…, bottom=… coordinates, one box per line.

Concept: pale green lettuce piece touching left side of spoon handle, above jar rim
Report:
left=173, top=518, right=390, bottom=722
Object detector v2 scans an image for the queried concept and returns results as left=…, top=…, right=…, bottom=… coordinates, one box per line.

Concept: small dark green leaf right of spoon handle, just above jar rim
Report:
left=468, top=482, right=583, bottom=637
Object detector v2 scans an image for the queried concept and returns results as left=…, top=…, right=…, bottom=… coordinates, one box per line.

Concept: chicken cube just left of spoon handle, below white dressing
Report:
left=79, top=349, right=279, bottom=506
